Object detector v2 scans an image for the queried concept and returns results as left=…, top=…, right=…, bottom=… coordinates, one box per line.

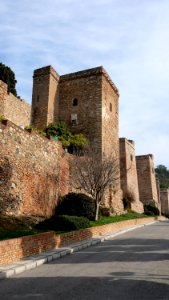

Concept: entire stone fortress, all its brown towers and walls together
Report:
left=0, top=66, right=164, bottom=216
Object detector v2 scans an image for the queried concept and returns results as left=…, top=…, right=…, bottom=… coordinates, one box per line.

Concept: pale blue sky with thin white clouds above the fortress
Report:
left=0, top=0, right=169, bottom=168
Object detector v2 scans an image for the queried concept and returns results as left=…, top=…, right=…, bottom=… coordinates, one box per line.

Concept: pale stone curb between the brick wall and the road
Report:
left=0, top=221, right=158, bottom=279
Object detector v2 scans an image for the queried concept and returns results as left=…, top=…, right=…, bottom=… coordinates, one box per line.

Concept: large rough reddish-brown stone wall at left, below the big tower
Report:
left=0, top=121, right=69, bottom=217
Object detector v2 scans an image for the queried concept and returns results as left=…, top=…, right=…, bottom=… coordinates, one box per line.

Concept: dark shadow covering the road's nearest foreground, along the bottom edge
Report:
left=0, top=272, right=169, bottom=300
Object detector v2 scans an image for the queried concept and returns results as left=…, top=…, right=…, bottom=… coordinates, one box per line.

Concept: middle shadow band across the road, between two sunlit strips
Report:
left=47, top=238, right=169, bottom=264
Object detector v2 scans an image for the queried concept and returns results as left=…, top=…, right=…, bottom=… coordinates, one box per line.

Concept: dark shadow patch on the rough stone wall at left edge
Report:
left=0, top=157, right=21, bottom=214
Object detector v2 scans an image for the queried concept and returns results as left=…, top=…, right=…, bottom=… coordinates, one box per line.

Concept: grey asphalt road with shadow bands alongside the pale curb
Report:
left=0, top=221, right=169, bottom=300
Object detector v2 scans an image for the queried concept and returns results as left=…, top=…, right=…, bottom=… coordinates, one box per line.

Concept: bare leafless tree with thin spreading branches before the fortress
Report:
left=73, top=150, right=120, bottom=220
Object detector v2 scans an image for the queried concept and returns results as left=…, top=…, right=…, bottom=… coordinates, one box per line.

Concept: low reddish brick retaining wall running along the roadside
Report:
left=0, top=217, right=165, bottom=265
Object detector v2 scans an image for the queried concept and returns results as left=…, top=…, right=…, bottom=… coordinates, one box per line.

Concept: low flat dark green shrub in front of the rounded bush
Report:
left=36, top=215, right=90, bottom=231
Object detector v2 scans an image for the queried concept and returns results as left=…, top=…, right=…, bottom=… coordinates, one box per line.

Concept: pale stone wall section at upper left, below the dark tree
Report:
left=0, top=80, right=31, bottom=128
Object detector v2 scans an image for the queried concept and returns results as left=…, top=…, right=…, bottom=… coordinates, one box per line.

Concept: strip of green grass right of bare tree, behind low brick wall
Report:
left=90, top=212, right=148, bottom=227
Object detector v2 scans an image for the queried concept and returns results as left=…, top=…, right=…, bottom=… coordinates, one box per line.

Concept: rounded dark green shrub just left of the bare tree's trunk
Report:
left=56, top=193, right=96, bottom=220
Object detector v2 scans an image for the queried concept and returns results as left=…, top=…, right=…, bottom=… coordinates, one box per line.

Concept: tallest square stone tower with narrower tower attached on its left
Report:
left=31, top=66, right=123, bottom=213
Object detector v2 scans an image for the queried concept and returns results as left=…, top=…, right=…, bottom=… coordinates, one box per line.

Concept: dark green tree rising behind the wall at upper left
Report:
left=0, top=63, right=17, bottom=97
